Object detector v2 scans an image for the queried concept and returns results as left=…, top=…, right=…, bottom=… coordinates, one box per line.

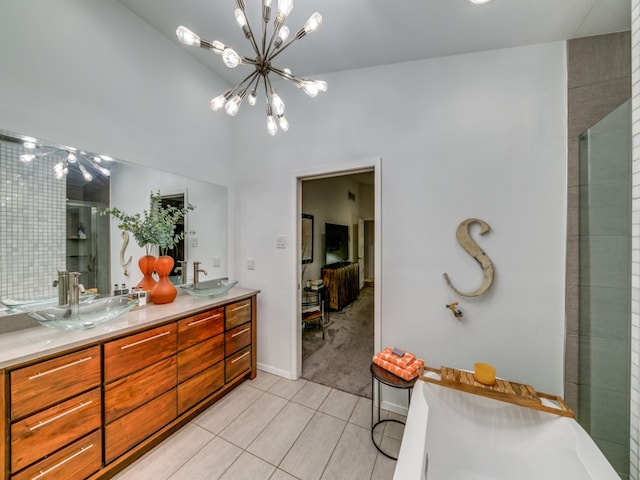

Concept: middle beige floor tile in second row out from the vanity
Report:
left=220, top=392, right=287, bottom=449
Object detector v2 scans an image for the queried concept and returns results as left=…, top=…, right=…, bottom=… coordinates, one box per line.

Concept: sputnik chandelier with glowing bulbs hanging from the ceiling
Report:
left=176, top=0, right=327, bottom=135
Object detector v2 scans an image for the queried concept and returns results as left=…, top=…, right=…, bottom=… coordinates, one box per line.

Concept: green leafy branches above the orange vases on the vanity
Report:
left=101, top=192, right=195, bottom=255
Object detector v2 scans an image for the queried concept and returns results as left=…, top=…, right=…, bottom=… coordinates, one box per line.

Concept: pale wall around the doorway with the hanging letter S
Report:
left=231, top=42, right=567, bottom=394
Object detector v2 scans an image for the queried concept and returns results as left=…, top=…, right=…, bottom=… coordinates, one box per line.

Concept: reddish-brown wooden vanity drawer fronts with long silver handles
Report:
left=0, top=293, right=256, bottom=480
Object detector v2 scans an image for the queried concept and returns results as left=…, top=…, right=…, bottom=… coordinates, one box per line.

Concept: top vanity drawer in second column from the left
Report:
left=104, top=323, right=176, bottom=383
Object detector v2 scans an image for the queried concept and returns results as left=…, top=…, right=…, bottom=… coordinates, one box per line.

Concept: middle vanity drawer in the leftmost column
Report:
left=11, top=388, right=101, bottom=472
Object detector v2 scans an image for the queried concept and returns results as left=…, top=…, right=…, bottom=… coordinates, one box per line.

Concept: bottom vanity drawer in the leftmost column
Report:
left=11, top=430, right=102, bottom=480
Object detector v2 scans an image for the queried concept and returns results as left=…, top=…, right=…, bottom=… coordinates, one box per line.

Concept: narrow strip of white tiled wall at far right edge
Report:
left=629, top=0, right=640, bottom=480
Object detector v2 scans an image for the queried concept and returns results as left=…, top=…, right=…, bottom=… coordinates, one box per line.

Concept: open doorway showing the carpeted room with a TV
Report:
left=294, top=165, right=381, bottom=396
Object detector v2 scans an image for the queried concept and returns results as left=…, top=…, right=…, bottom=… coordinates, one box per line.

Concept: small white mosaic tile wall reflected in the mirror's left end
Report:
left=0, top=142, right=66, bottom=299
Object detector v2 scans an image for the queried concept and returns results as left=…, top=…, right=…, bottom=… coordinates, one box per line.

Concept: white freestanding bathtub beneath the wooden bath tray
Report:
left=393, top=373, right=620, bottom=480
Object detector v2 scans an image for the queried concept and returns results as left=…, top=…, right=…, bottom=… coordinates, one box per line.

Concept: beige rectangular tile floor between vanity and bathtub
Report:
left=115, top=371, right=403, bottom=480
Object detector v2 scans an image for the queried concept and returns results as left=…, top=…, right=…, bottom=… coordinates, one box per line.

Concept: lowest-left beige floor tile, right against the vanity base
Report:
left=115, top=424, right=214, bottom=480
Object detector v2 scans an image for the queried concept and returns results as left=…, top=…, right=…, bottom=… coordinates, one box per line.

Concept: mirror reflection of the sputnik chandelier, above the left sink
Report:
left=19, top=139, right=113, bottom=182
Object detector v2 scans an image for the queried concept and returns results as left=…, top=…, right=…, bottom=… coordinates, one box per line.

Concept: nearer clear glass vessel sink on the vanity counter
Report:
left=28, top=297, right=138, bottom=330
